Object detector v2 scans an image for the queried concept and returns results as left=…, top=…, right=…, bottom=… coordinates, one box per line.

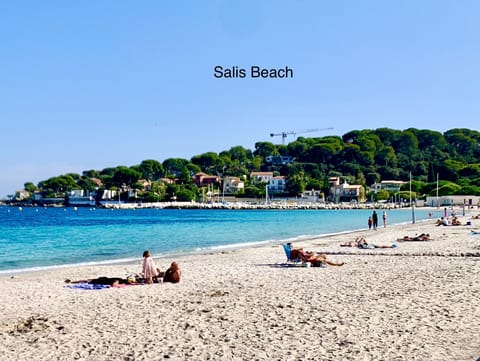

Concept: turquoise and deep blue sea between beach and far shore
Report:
left=0, top=207, right=441, bottom=274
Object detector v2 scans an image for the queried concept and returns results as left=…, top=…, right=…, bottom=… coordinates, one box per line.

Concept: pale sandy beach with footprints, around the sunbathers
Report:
left=0, top=212, right=480, bottom=361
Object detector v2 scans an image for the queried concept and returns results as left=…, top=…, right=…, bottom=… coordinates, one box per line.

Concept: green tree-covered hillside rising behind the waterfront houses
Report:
left=16, top=128, right=480, bottom=201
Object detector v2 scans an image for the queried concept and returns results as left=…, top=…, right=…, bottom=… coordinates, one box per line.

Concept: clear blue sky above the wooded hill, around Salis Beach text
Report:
left=0, top=0, right=480, bottom=198
